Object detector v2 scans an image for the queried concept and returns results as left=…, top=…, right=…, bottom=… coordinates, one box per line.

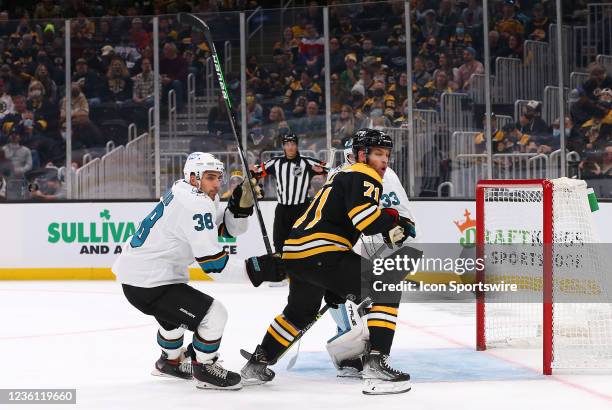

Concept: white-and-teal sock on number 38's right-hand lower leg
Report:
left=193, top=299, right=227, bottom=363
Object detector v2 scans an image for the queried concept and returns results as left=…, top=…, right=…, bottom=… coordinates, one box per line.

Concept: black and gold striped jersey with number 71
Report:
left=283, top=163, right=394, bottom=259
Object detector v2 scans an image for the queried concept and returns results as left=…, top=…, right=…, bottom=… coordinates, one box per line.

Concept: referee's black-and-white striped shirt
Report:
left=257, top=153, right=325, bottom=205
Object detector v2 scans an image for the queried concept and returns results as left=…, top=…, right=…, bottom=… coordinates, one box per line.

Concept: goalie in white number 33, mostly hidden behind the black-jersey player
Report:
left=326, top=139, right=416, bottom=378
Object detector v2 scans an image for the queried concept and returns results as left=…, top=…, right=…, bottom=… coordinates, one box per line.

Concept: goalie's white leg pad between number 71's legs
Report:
left=326, top=300, right=369, bottom=369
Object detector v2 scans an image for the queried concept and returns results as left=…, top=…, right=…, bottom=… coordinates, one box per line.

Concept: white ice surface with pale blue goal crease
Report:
left=0, top=281, right=612, bottom=410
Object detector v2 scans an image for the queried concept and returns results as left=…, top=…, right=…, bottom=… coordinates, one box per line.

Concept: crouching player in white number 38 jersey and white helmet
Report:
left=112, top=152, right=260, bottom=390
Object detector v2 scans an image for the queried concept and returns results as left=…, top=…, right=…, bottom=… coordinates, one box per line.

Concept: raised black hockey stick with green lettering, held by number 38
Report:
left=178, top=13, right=273, bottom=255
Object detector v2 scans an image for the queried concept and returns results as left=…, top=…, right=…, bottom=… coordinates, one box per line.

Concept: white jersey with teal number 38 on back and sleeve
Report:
left=112, top=180, right=248, bottom=288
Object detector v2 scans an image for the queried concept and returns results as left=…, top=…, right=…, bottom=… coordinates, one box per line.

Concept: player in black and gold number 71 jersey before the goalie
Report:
left=241, top=129, right=414, bottom=394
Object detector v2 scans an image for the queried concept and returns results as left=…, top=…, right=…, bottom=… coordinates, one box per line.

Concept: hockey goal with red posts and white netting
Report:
left=477, top=178, right=612, bottom=374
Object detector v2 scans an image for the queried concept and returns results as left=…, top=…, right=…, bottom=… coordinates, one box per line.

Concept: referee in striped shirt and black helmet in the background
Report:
left=251, top=134, right=327, bottom=253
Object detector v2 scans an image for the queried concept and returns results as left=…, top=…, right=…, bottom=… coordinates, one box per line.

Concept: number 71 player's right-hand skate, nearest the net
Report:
left=362, top=352, right=411, bottom=394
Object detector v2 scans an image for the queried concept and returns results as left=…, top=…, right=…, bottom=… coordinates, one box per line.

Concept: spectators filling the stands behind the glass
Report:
left=0, top=0, right=612, bottom=197
